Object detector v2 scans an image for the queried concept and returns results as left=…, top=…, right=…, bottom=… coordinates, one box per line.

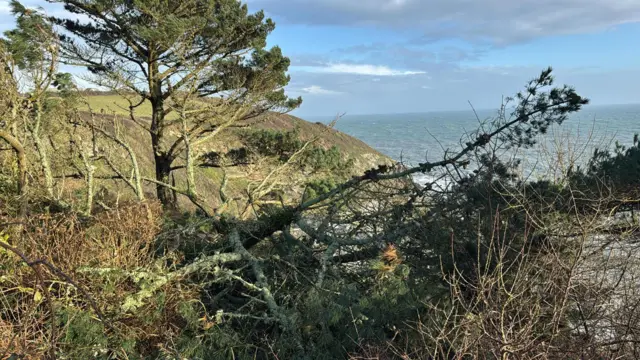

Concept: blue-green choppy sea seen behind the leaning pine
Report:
left=306, top=104, right=640, bottom=183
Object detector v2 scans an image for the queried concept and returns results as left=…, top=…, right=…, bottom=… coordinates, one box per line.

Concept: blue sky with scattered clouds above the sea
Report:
left=0, top=0, right=640, bottom=117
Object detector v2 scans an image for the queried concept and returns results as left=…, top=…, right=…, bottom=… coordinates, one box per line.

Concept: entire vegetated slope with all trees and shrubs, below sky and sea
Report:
left=0, top=0, right=640, bottom=360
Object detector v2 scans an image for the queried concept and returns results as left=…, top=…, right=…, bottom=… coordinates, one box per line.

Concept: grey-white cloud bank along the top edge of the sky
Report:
left=253, top=0, right=640, bottom=44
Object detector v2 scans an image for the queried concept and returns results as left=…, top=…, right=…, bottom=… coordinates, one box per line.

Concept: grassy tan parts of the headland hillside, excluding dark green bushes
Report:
left=81, top=94, right=391, bottom=212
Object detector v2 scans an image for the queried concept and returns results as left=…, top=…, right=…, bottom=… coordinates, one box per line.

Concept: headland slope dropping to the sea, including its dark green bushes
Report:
left=72, top=91, right=393, bottom=212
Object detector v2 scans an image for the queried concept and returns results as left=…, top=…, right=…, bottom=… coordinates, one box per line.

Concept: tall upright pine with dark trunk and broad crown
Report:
left=48, top=0, right=302, bottom=207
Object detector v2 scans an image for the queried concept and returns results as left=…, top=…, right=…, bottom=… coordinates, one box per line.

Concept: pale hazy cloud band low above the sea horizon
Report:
left=288, top=66, right=640, bottom=117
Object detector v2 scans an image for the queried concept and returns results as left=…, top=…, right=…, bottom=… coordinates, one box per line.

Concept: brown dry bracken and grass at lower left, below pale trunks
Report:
left=0, top=202, right=202, bottom=359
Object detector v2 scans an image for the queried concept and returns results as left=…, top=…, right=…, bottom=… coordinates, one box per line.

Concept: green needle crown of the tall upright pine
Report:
left=53, top=0, right=301, bottom=108
